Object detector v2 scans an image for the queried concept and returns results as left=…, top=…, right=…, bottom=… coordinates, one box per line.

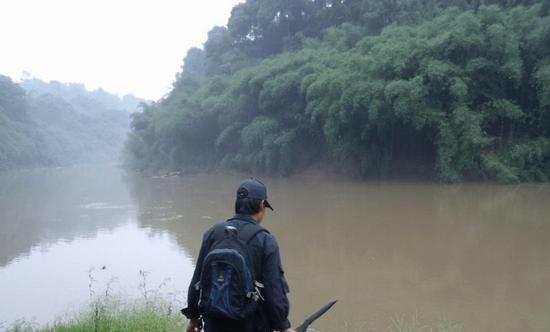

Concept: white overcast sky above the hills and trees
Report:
left=0, top=0, right=242, bottom=100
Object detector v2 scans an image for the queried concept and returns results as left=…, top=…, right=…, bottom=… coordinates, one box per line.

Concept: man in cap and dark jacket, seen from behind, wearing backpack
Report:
left=182, top=178, right=295, bottom=332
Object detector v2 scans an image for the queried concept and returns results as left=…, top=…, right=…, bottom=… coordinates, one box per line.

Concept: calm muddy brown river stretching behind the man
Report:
left=0, top=166, right=550, bottom=332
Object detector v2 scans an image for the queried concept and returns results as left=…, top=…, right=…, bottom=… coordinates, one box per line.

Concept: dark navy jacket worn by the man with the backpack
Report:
left=182, top=214, right=290, bottom=332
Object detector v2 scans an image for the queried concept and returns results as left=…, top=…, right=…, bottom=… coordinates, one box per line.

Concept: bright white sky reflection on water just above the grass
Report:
left=0, top=222, right=192, bottom=324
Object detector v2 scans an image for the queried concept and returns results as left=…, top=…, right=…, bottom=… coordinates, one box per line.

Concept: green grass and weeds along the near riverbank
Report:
left=0, top=268, right=462, bottom=332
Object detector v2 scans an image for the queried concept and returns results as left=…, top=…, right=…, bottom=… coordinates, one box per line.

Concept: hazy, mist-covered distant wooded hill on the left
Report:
left=0, top=75, right=141, bottom=171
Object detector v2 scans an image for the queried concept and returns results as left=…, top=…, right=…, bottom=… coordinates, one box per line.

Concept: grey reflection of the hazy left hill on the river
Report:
left=0, top=167, right=135, bottom=267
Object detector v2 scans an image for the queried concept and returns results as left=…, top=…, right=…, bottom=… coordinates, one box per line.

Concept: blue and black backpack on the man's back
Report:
left=196, top=219, right=267, bottom=321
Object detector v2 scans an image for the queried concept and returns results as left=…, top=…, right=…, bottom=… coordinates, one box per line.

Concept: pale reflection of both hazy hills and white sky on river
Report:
left=0, top=167, right=193, bottom=329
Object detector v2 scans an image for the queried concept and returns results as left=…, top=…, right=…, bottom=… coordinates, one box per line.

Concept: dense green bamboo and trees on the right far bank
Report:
left=126, top=0, right=550, bottom=182
